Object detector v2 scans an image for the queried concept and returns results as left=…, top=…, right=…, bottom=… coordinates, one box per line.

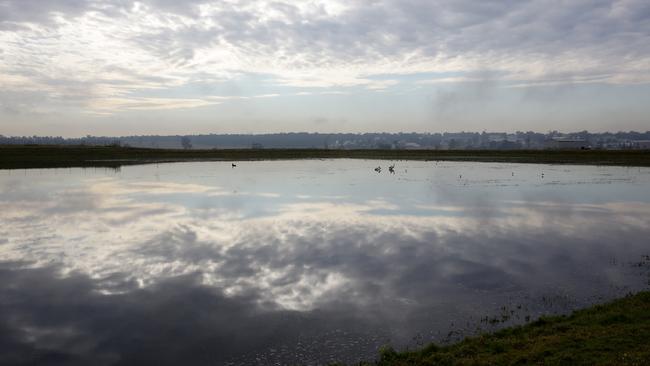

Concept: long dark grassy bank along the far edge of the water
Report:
left=0, top=145, right=650, bottom=169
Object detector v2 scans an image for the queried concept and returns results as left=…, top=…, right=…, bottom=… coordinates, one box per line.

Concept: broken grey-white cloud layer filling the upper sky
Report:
left=0, top=0, right=650, bottom=117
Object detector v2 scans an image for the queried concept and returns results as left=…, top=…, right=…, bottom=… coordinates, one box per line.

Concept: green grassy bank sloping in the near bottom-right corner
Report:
left=366, top=292, right=650, bottom=366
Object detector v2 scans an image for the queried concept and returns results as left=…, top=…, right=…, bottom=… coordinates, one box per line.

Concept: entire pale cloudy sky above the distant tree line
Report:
left=0, top=0, right=650, bottom=137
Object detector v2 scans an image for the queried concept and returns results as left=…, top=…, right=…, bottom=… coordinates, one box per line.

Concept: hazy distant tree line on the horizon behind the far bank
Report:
left=0, top=131, right=650, bottom=150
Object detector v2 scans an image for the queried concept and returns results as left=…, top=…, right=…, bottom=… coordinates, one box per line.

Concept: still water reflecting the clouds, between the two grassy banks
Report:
left=0, top=160, right=650, bottom=365
